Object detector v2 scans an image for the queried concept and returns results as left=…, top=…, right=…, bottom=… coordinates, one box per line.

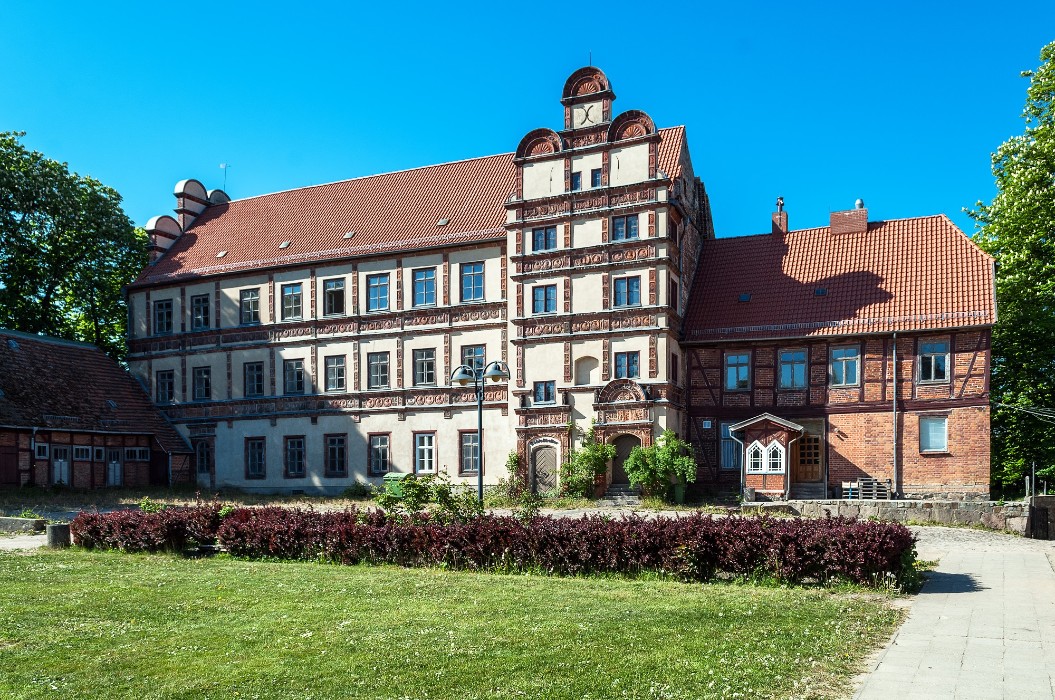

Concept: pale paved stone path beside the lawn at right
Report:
left=853, top=527, right=1055, bottom=700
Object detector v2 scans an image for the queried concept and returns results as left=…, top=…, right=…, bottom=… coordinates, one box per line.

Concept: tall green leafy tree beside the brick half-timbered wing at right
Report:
left=970, top=42, right=1055, bottom=484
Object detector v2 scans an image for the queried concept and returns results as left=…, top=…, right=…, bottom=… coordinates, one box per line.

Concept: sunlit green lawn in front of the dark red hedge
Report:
left=0, top=550, right=900, bottom=700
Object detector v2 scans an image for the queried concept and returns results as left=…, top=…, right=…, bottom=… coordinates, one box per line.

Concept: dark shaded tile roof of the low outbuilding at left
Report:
left=0, top=329, right=191, bottom=452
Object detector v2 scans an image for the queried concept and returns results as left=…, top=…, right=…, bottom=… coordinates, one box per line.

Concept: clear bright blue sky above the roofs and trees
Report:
left=0, top=0, right=1055, bottom=235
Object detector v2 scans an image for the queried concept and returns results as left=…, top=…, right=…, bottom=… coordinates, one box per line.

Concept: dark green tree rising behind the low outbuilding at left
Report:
left=0, top=132, right=147, bottom=358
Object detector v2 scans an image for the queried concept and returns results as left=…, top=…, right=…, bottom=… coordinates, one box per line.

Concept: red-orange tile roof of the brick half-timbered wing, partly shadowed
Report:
left=684, top=215, right=996, bottom=343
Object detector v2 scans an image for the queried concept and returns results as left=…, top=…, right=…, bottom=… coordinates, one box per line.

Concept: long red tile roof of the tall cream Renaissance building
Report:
left=133, top=127, right=685, bottom=286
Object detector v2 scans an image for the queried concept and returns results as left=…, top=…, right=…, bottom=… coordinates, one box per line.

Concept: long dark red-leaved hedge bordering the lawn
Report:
left=71, top=505, right=915, bottom=585
